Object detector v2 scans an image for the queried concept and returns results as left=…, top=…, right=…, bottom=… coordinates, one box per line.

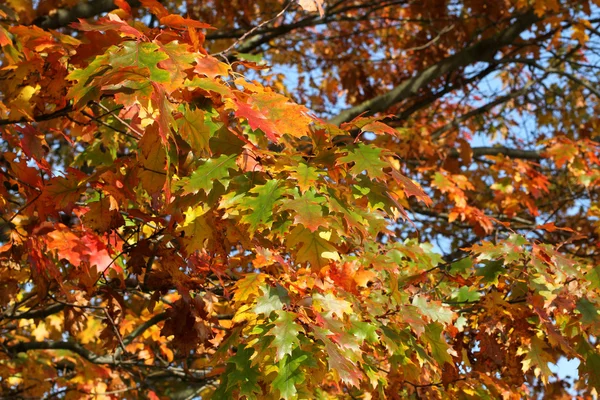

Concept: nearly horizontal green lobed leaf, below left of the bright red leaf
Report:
left=181, top=154, right=238, bottom=194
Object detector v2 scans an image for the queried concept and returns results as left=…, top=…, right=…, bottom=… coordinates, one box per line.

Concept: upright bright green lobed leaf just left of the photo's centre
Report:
left=239, top=179, right=284, bottom=232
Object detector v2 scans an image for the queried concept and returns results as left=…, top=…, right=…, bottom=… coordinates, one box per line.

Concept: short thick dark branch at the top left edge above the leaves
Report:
left=33, top=0, right=140, bottom=29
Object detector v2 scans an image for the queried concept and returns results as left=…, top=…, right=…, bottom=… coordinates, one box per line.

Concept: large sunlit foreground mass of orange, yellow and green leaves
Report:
left=0, top=0, right=600, bottom=399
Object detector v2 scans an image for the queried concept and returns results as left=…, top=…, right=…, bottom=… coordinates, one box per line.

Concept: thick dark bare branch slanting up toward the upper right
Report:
left=329, top=12, right=538, bottom=125
